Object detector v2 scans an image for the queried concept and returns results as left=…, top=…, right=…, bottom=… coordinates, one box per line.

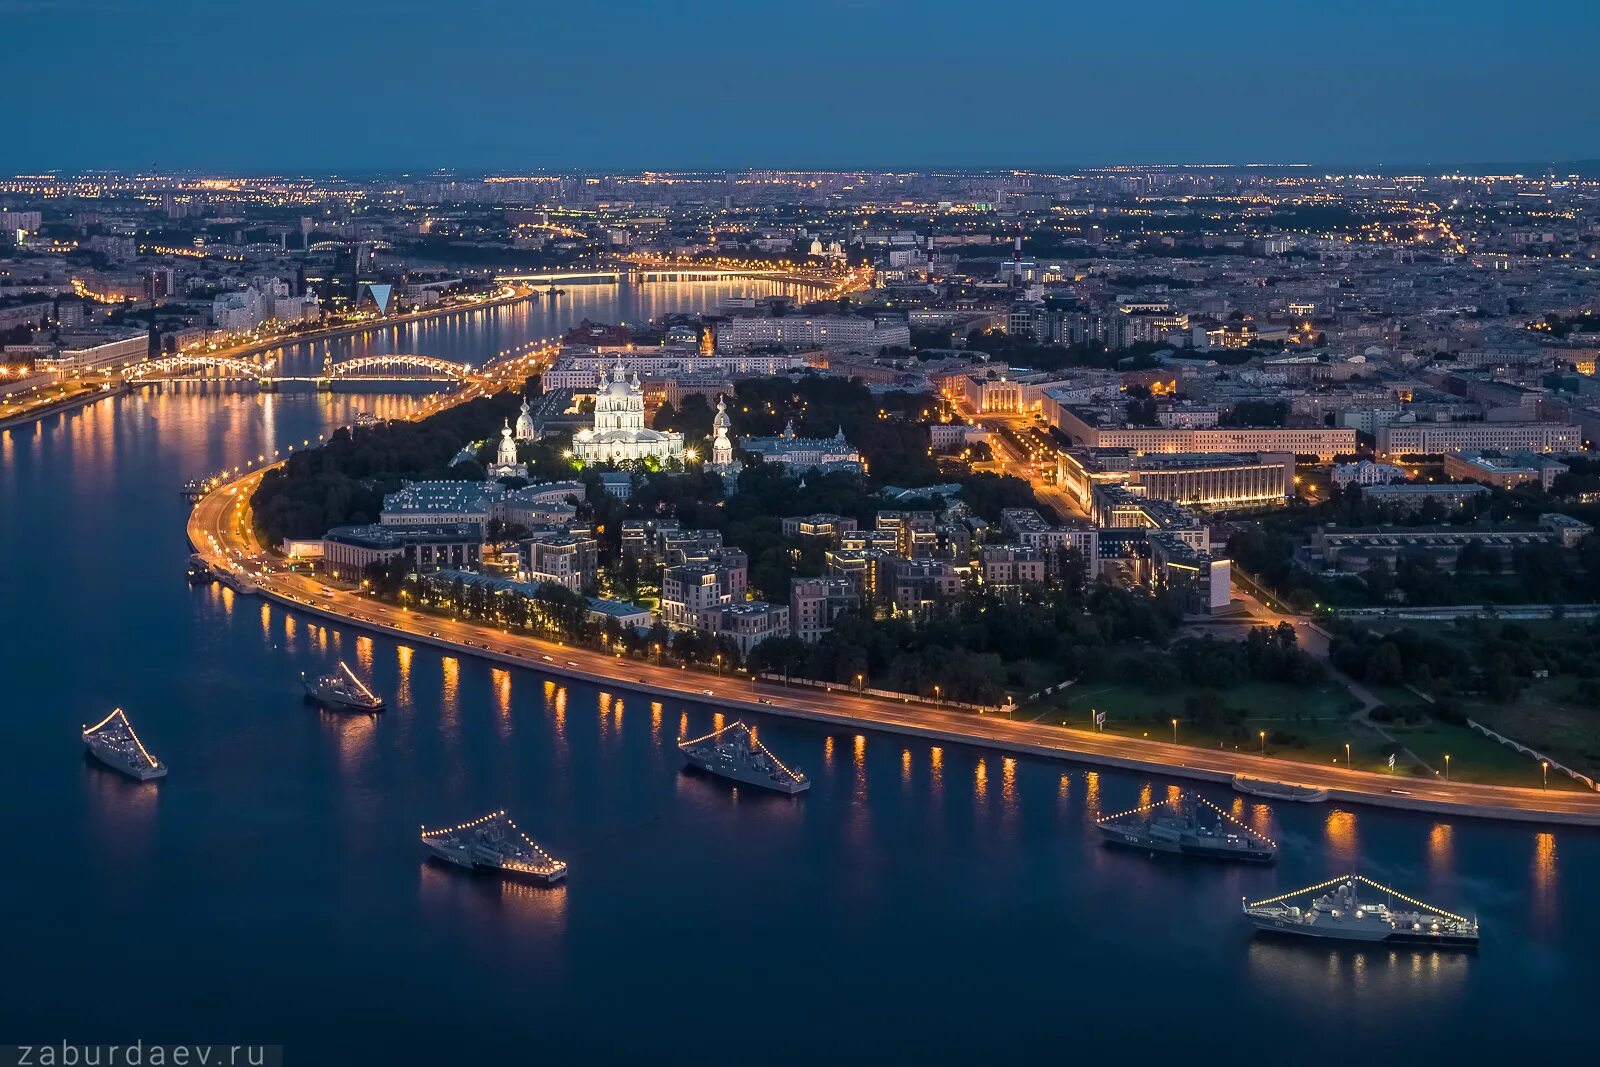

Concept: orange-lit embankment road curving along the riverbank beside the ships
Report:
left=187, top=464, right=1600, bottom=827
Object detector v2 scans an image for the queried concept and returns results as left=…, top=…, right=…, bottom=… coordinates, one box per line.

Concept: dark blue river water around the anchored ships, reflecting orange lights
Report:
left=0, top=279, right=1600, bottom=1064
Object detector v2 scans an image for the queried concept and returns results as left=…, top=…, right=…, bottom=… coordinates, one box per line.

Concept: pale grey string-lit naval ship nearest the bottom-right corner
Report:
left=1243, top=875, right=1478, bottom=949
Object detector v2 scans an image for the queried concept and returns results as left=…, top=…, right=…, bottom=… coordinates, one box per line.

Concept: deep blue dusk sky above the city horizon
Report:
left=12, top=0, right=1600, bottom=173
